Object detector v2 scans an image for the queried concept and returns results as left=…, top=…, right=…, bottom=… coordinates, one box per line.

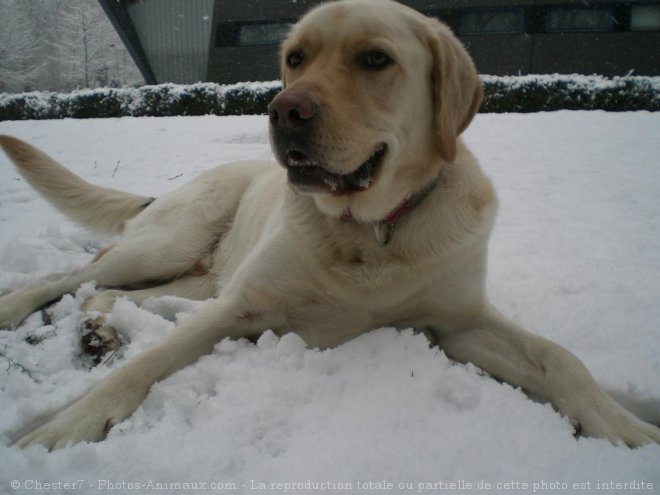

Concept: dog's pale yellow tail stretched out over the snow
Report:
left=0, top=135, right=153, bottom=234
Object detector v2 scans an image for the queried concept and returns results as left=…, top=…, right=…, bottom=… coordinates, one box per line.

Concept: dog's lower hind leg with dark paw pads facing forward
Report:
left=80, top=273, right=216, bottom=363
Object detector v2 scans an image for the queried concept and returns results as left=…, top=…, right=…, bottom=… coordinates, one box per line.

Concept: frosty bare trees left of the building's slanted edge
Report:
left=0, top=0, right=142, bottom=92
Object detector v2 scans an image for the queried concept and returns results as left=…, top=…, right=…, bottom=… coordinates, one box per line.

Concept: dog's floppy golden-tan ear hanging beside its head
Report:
left=427, top=19, right=483, bottom=162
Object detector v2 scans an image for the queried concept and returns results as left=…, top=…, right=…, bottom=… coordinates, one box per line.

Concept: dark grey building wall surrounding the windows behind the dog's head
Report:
left=207, top=0, right=660, bottom=83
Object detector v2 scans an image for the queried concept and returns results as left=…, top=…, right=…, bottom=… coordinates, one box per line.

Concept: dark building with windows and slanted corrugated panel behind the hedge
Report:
left=100, top=0, right=660, bottom=83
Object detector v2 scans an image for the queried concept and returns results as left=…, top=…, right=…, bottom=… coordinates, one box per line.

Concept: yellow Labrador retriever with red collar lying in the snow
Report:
left=0, top=0, right=660, bottom=449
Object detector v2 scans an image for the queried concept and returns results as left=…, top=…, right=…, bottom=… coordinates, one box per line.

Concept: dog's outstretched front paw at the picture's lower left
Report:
left=15, top=399, right=115, bottom=451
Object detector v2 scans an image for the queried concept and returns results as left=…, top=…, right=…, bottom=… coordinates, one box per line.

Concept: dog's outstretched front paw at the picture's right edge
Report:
left=574, top=397, right=660, bottom=448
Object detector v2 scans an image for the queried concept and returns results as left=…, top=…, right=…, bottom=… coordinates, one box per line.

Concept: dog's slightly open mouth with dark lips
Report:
left=285, top=144, right=387, bottom=196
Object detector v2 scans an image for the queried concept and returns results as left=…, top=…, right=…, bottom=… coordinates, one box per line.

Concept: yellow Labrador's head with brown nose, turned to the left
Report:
left=268, top=0, right=481, bottom=222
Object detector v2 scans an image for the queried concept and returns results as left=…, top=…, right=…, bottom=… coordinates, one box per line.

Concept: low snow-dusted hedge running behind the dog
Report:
left=0, top=75, right=660, bottom=120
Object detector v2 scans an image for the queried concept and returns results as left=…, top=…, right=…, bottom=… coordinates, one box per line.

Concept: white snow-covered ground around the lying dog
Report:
left=0, top=112, right=660, bottom=494
